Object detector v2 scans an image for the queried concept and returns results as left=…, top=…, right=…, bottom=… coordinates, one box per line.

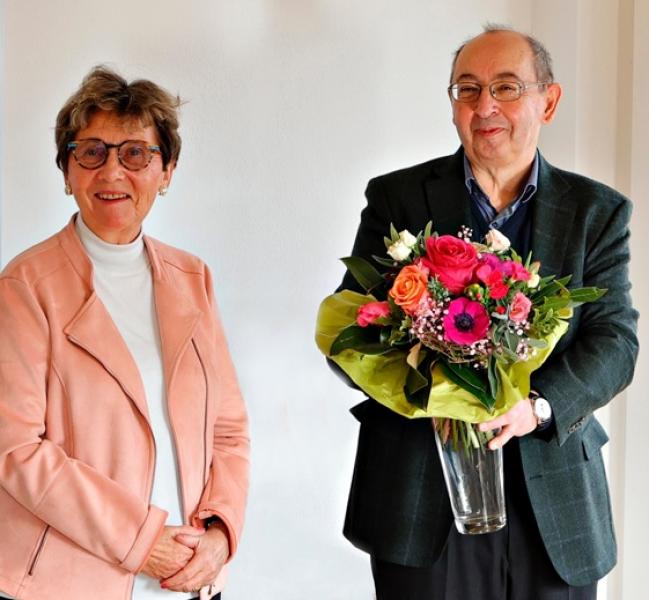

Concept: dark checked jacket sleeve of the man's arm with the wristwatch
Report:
left=532, top=199, right=638, bottom=445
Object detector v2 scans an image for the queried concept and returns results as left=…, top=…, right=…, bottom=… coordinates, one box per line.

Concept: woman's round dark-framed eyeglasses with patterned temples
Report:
left=67, top=138, right=160, bottom=171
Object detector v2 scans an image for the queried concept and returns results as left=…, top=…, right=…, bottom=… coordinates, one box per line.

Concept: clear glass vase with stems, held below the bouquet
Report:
left=435, top=419, right=507, bottom=535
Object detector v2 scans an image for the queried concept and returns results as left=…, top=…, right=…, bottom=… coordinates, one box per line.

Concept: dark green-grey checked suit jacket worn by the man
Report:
left=341, top=150, right=638, bottom=586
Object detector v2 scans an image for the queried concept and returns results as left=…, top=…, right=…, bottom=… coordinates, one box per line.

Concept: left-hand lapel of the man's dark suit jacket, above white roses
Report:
left=424, top=148, right=471, bottom=235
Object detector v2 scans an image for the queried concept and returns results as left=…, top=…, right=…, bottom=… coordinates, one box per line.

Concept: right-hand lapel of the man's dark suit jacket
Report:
left=532, top=156, right=577, bottom=276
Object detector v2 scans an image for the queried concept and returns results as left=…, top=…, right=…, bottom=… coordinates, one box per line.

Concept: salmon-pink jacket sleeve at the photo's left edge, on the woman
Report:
left=0, top=277, right=166, bottom=572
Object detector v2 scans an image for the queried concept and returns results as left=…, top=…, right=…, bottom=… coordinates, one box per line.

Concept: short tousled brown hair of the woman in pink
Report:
left=54, top=65, right=181, bottom=173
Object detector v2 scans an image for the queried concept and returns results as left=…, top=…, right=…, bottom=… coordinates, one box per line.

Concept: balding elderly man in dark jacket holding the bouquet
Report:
left=342, top=28, right=638, bottom=600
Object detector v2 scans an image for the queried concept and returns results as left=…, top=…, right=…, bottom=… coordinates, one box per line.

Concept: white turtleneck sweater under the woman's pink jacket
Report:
left=76, top=214, right=195, bottom=600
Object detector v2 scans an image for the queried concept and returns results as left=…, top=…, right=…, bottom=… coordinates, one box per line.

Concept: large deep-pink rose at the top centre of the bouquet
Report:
left=422, top=235, right=478, bottom=294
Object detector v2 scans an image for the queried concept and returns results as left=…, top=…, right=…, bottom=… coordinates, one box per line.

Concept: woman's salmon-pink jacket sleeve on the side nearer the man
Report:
left=194, top=267, right=250, bottom=560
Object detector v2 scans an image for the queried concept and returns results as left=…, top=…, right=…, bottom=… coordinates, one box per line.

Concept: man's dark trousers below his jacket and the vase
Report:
left=371, top=441, right=597, bottom=600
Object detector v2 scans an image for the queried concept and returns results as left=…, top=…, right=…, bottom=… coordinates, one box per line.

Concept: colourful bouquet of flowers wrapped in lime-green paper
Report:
left=316, top=223, right=606, bottom=445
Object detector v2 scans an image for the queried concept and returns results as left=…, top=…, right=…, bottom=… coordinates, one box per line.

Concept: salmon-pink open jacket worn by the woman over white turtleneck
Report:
left=0, top=221, right=249, bottom=600
